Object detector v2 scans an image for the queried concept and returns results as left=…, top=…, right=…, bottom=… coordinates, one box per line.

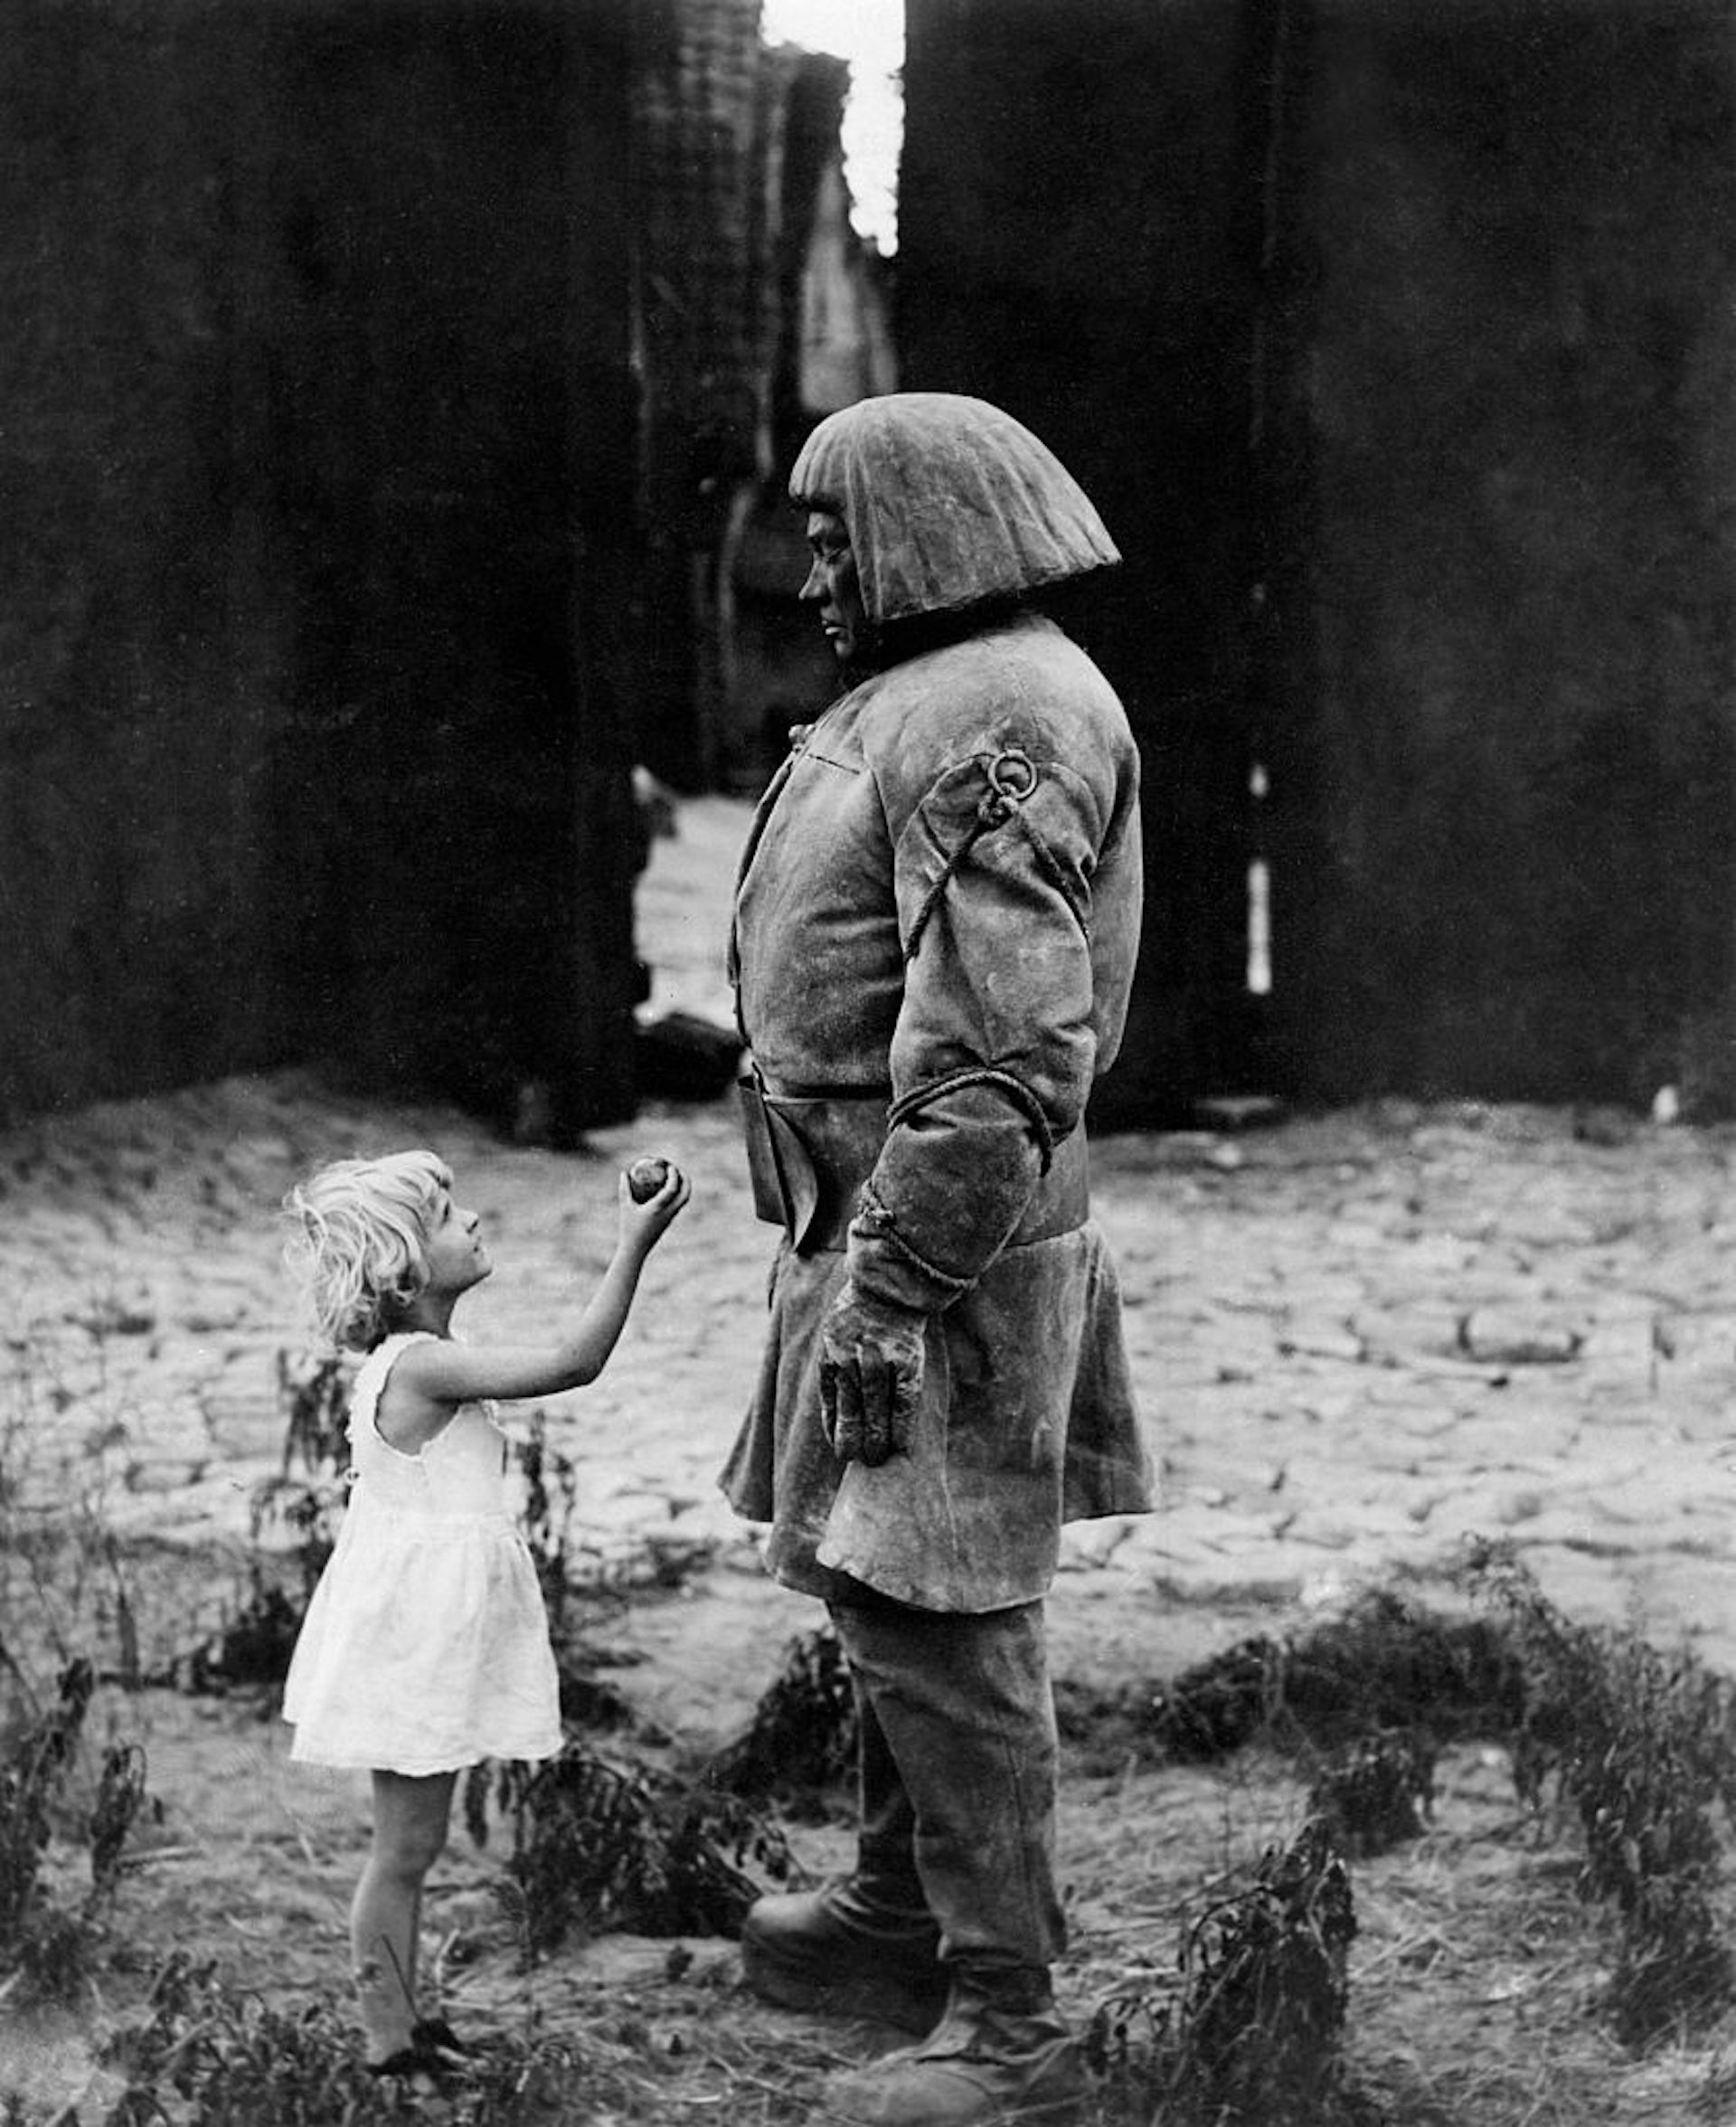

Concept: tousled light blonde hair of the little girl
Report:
left=283, top=1150, right=451, bottom=1351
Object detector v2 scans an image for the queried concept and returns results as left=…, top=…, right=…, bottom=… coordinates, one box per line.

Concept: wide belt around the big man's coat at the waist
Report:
left=736, top=1074, right=1091, bottom=1255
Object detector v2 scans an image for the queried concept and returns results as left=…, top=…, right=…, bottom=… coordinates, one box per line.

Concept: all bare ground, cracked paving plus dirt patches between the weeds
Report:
left=0, top=799, right=1736, bottom=2127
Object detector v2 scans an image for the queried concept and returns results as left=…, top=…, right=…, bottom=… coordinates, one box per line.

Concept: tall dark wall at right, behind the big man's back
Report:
left=900, top=0, right=1736, bottom=1111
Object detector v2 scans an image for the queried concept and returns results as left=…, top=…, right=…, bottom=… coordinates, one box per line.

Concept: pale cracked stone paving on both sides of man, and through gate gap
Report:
left=0, top=799, right=1736, bottom=1668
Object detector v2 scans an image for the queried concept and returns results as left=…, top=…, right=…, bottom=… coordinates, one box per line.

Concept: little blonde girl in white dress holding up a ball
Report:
left=283, top=1153, right=692, bottom=2076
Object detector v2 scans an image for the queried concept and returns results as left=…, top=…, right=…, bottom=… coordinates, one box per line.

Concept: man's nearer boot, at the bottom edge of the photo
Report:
left=819, top=1965, right=1087, bottom=2127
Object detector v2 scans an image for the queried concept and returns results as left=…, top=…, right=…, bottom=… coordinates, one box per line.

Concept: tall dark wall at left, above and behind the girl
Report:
left=0, top=0, right=637, bottom=1121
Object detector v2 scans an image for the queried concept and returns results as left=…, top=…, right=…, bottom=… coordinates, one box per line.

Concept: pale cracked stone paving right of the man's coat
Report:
left=1079, top=1104, right=1736, bottom=1668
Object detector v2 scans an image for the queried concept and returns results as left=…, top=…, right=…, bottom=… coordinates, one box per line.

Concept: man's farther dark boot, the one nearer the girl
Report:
left=742, top=1878, right=947, bottom=2031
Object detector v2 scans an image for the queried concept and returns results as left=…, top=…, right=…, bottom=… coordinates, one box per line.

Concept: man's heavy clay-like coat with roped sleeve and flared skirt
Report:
left=723, top=615, right=1151, bottom=1612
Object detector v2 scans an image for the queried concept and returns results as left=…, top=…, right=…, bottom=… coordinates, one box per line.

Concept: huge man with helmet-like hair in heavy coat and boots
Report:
left=723, top=392, right=1151, bottom=2127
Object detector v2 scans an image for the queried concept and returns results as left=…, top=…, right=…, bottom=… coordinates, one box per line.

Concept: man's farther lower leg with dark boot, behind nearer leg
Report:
left=741, top=1659, right=947, bottom=2031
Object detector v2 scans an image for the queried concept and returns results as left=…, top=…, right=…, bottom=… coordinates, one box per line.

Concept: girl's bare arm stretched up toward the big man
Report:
left=392, top=1166, right=693, bottom=1410
